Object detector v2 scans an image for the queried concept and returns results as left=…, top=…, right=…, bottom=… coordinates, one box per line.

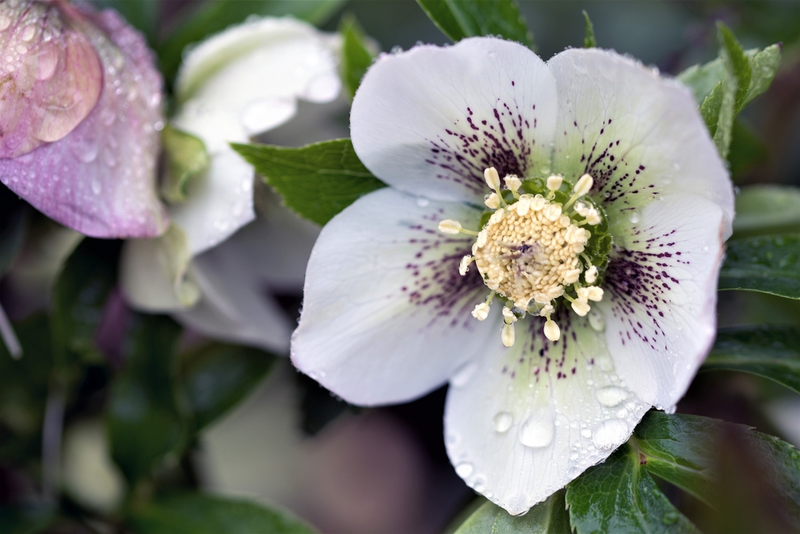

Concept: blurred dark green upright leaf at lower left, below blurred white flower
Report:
left=106, top=314, right=186, bottom=483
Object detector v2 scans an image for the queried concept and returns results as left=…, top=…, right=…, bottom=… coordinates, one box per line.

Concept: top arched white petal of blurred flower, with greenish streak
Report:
left=176, top=18, right=341, bottom=149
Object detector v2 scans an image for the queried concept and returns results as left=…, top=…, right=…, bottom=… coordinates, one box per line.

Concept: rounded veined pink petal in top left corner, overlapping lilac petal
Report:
left=0, top=1, right=103, bottom=158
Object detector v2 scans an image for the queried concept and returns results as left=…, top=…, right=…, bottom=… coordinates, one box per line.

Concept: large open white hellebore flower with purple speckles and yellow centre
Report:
left=292, top=38, right=733, bottom=514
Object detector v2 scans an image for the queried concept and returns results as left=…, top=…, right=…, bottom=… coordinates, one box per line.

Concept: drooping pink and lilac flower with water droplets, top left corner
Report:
left=0, top=0, right=167, bottom=238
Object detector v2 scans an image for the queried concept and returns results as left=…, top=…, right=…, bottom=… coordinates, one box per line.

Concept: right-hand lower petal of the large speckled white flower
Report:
left=593, top=195, right=726, bottom=409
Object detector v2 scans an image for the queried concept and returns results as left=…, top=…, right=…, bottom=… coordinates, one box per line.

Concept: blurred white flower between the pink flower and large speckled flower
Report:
left=121, top=18, right=341, bottom=351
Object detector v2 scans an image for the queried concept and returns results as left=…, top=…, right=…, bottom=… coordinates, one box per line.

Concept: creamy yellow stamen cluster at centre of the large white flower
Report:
left=439, top=167, right=603, bottom=347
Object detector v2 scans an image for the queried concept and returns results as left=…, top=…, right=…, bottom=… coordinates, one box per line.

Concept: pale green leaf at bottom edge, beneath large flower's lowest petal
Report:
left=453, top=491, right=572, bottom=534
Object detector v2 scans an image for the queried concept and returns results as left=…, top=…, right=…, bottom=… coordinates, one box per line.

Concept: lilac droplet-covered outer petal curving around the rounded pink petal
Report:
left=0, top=4, right=167, bottom=238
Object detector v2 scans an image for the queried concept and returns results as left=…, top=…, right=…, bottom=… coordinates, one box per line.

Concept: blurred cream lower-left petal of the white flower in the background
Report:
left=120, top=224, right=200, bottom=312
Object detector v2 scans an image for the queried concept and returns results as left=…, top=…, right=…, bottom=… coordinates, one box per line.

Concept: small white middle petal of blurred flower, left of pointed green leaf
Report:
left=169, top=146, right=255, bottom=255
